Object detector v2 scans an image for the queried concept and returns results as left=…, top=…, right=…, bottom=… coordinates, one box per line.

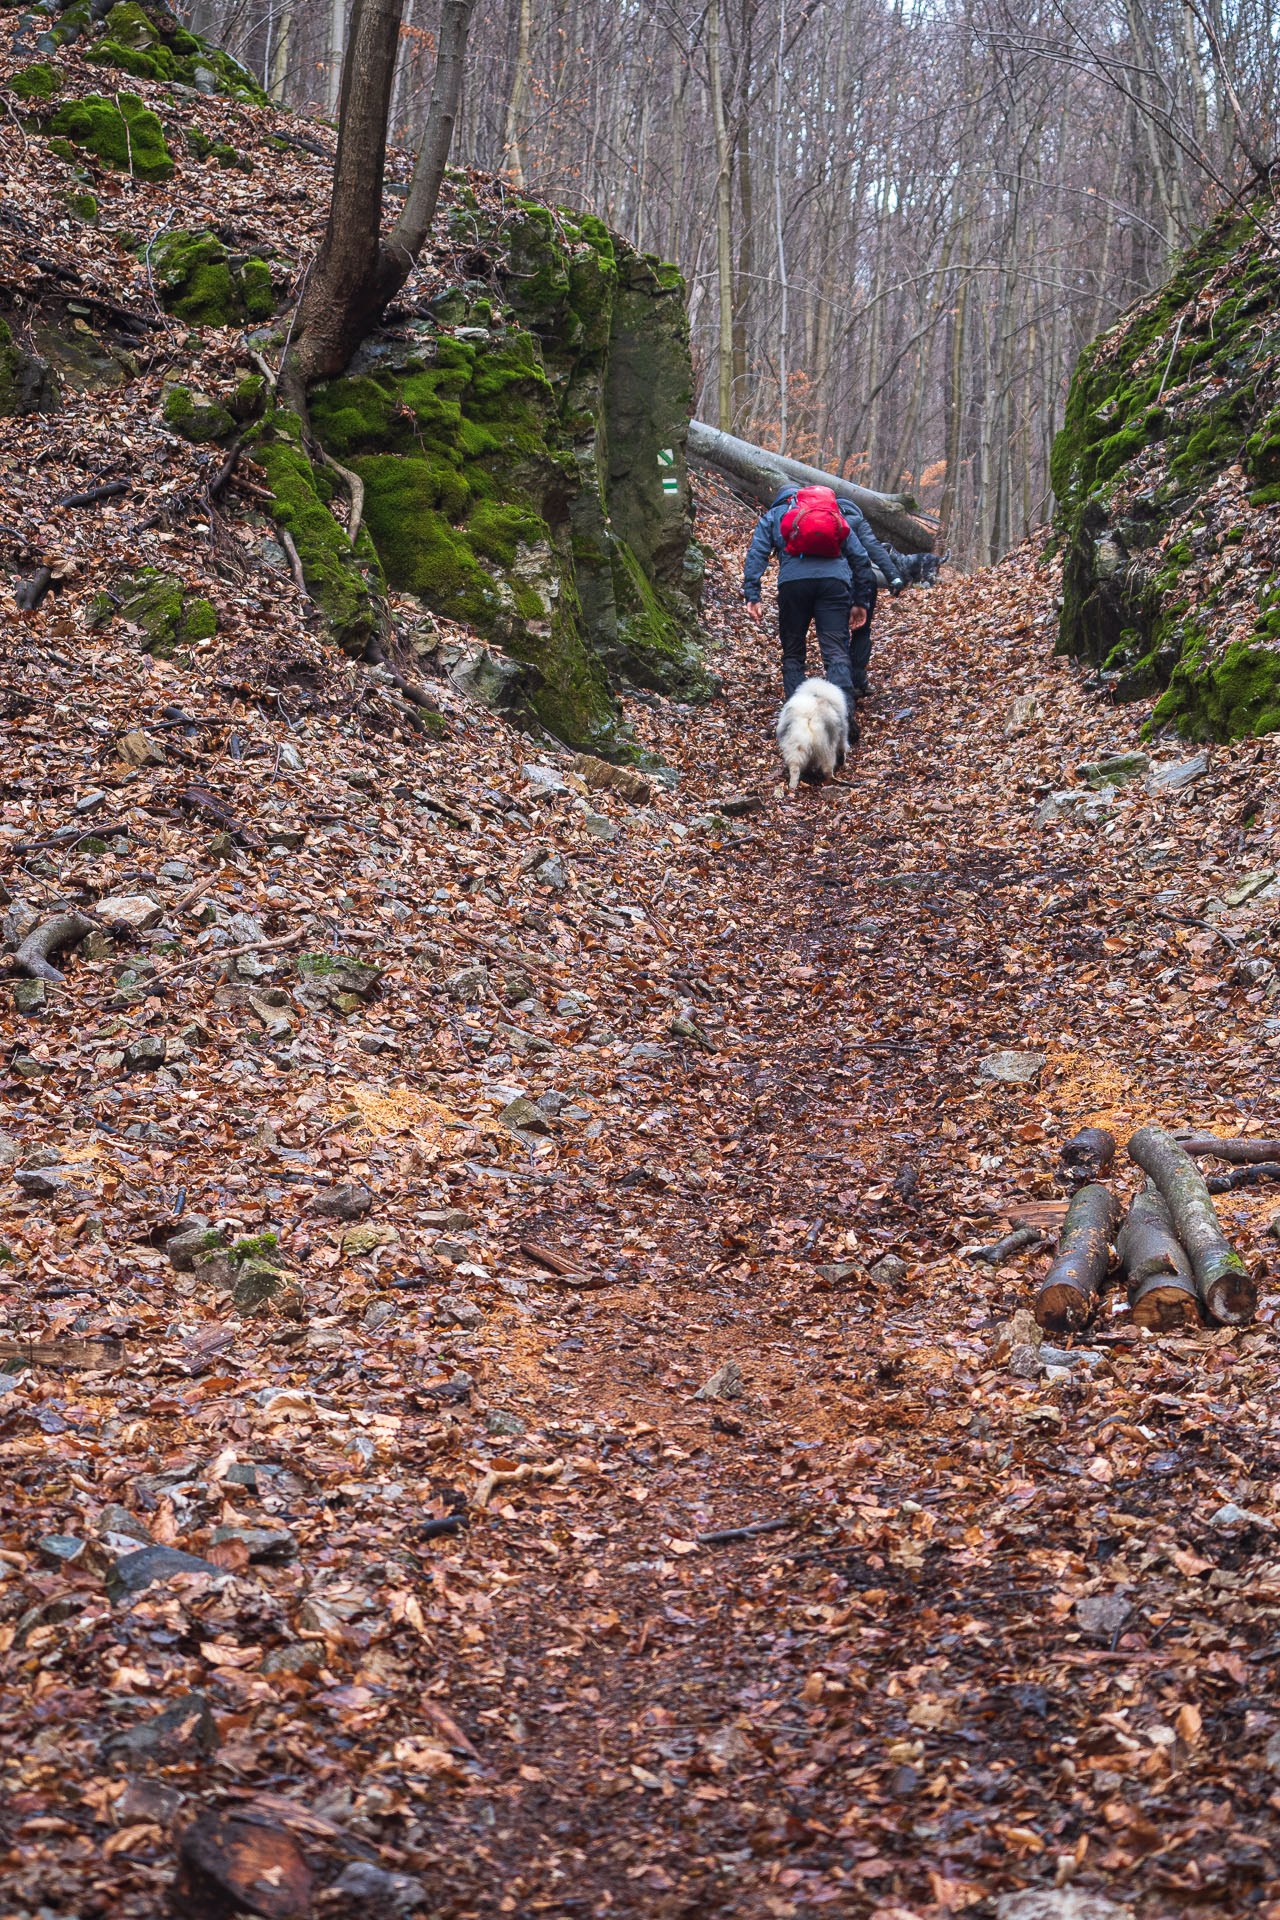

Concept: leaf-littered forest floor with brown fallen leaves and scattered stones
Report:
left=0, top=468, right=1280, bottom=1920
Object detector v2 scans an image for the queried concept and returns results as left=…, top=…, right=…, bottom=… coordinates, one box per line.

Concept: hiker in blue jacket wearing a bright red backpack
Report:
left=743, top=484, right=875, bottom=710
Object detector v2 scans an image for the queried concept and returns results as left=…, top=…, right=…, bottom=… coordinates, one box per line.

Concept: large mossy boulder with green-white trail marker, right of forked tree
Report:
left=301, top=202, right=712, bottom=753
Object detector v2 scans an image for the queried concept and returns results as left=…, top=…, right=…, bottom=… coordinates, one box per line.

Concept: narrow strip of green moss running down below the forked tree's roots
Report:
left=246, top=407, right=386, bottom=659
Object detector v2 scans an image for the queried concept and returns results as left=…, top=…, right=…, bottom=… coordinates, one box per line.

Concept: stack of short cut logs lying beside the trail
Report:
left=1036, top=1127, right=1258, bottom=1332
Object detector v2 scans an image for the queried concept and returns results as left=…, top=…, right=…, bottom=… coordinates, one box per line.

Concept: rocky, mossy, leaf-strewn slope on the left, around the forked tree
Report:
left=0, top=0, right=712, bottom=755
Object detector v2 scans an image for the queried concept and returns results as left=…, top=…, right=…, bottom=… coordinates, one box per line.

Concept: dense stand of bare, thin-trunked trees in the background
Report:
left=172, top=0, right=1280, bottom=564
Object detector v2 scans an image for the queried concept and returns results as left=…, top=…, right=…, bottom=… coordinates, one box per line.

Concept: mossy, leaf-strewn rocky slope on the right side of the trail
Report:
left=1054, top=202, right=1280, bottom=739
